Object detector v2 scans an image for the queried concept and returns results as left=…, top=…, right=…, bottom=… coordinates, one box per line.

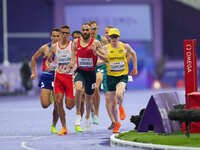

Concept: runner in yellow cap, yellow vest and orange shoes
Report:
left=104, top=28, right=137, bottom=133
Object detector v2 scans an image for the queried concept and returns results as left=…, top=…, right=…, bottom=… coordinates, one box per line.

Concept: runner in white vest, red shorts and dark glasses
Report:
left=48, top=25, right=74, bottom=135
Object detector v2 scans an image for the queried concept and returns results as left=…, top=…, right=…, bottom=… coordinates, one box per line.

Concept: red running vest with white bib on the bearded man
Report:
left=76, top=38, right=97, bottom=71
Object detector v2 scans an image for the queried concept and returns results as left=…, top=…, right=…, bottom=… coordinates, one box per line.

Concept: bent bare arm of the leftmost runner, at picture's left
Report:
left=31, top=45, right=46, bottom=80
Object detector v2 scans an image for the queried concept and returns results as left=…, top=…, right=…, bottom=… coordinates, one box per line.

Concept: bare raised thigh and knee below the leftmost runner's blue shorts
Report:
left=40, top=88, right=51, bottom=108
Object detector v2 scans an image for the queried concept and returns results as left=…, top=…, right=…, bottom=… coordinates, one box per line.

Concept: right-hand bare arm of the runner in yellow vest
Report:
left=124, top=44, right=138, bottom=76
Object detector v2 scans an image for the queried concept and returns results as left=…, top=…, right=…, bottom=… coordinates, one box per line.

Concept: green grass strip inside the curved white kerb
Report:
left=116, top=130, right=200, bottom=147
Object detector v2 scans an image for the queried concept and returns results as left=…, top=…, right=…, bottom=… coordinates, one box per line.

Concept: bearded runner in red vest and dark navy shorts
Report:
left=71, top=23, right=107, bottom=132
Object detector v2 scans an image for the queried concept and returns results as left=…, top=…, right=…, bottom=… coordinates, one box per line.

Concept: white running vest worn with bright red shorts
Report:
left=56, top=41, right=73, bottom=74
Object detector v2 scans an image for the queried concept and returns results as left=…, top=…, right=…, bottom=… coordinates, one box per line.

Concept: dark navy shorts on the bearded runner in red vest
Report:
left=74, top=68, right=96, bottom=95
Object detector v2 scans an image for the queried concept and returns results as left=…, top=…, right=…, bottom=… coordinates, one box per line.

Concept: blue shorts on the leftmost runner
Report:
left=38, top=71, right=55, bottom=90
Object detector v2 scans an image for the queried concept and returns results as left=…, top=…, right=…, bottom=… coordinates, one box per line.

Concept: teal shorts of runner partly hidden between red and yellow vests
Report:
left=95, top=63, right=108, bottom=93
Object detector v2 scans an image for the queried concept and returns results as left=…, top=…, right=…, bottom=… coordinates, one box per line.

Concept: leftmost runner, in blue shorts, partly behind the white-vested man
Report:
left=31, top=28, right=60, bottom=133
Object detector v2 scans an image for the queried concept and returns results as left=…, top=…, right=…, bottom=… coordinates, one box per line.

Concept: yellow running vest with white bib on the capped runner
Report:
left=106, top=42, right=128, bottom=76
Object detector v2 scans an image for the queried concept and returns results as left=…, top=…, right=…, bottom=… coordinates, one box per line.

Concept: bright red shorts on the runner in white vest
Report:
left=54, top=72, right=75, bottom=99
